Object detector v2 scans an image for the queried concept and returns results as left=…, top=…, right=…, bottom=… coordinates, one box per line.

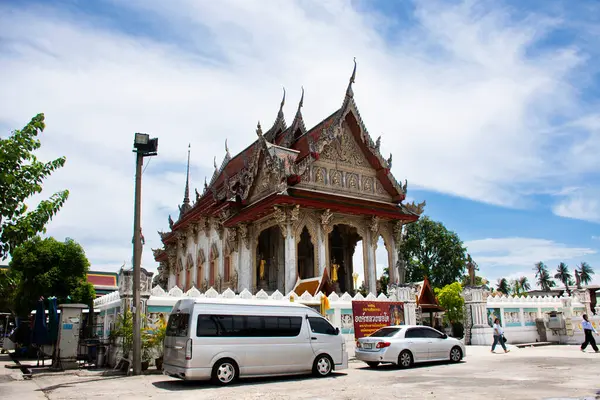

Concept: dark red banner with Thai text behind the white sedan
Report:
left=352, top=301, right=405, bottom=339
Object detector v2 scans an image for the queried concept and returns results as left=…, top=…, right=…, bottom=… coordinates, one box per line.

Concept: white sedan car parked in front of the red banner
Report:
left=356, top=325, right=466, bottom=368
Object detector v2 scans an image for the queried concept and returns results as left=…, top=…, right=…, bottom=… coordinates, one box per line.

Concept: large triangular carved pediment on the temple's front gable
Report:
left=299, top=122, right=392, bottom=202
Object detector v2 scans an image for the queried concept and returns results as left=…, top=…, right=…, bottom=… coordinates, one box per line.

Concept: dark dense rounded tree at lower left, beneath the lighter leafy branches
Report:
left=9, top=236, right=95, bottom=315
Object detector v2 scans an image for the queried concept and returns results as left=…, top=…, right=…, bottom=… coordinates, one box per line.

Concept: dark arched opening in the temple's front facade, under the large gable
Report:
left=329, top=225, right=362, bottom=293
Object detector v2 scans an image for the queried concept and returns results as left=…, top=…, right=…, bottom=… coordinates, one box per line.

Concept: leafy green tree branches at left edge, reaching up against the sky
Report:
left=0, top=114, right=69, bottom=259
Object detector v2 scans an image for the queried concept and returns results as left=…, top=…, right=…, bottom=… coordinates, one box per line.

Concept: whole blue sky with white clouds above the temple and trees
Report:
left=0, top=0, right=600, bottom=288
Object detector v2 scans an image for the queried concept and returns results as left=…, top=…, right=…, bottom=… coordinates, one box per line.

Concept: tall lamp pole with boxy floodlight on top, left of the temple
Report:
left=133, top=133, right=158, bottom=375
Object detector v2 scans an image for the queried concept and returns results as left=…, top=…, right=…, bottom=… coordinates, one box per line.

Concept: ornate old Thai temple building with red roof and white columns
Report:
left=153, top=64, right=424, bottom=293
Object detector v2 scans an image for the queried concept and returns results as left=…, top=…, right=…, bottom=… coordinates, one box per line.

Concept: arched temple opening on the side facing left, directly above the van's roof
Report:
left=256, top=226, right=285, bottom=293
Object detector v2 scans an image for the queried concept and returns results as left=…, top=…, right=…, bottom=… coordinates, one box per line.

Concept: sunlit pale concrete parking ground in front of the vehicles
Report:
left=0, top=346, right=600, bottom=400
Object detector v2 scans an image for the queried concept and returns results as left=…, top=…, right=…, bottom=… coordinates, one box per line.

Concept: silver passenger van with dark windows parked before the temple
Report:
left=163, top=299, right=348, bottom=385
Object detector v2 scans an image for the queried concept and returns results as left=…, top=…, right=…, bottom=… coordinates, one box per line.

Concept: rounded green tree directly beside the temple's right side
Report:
left=399, top=217, right=466, bottom=288
